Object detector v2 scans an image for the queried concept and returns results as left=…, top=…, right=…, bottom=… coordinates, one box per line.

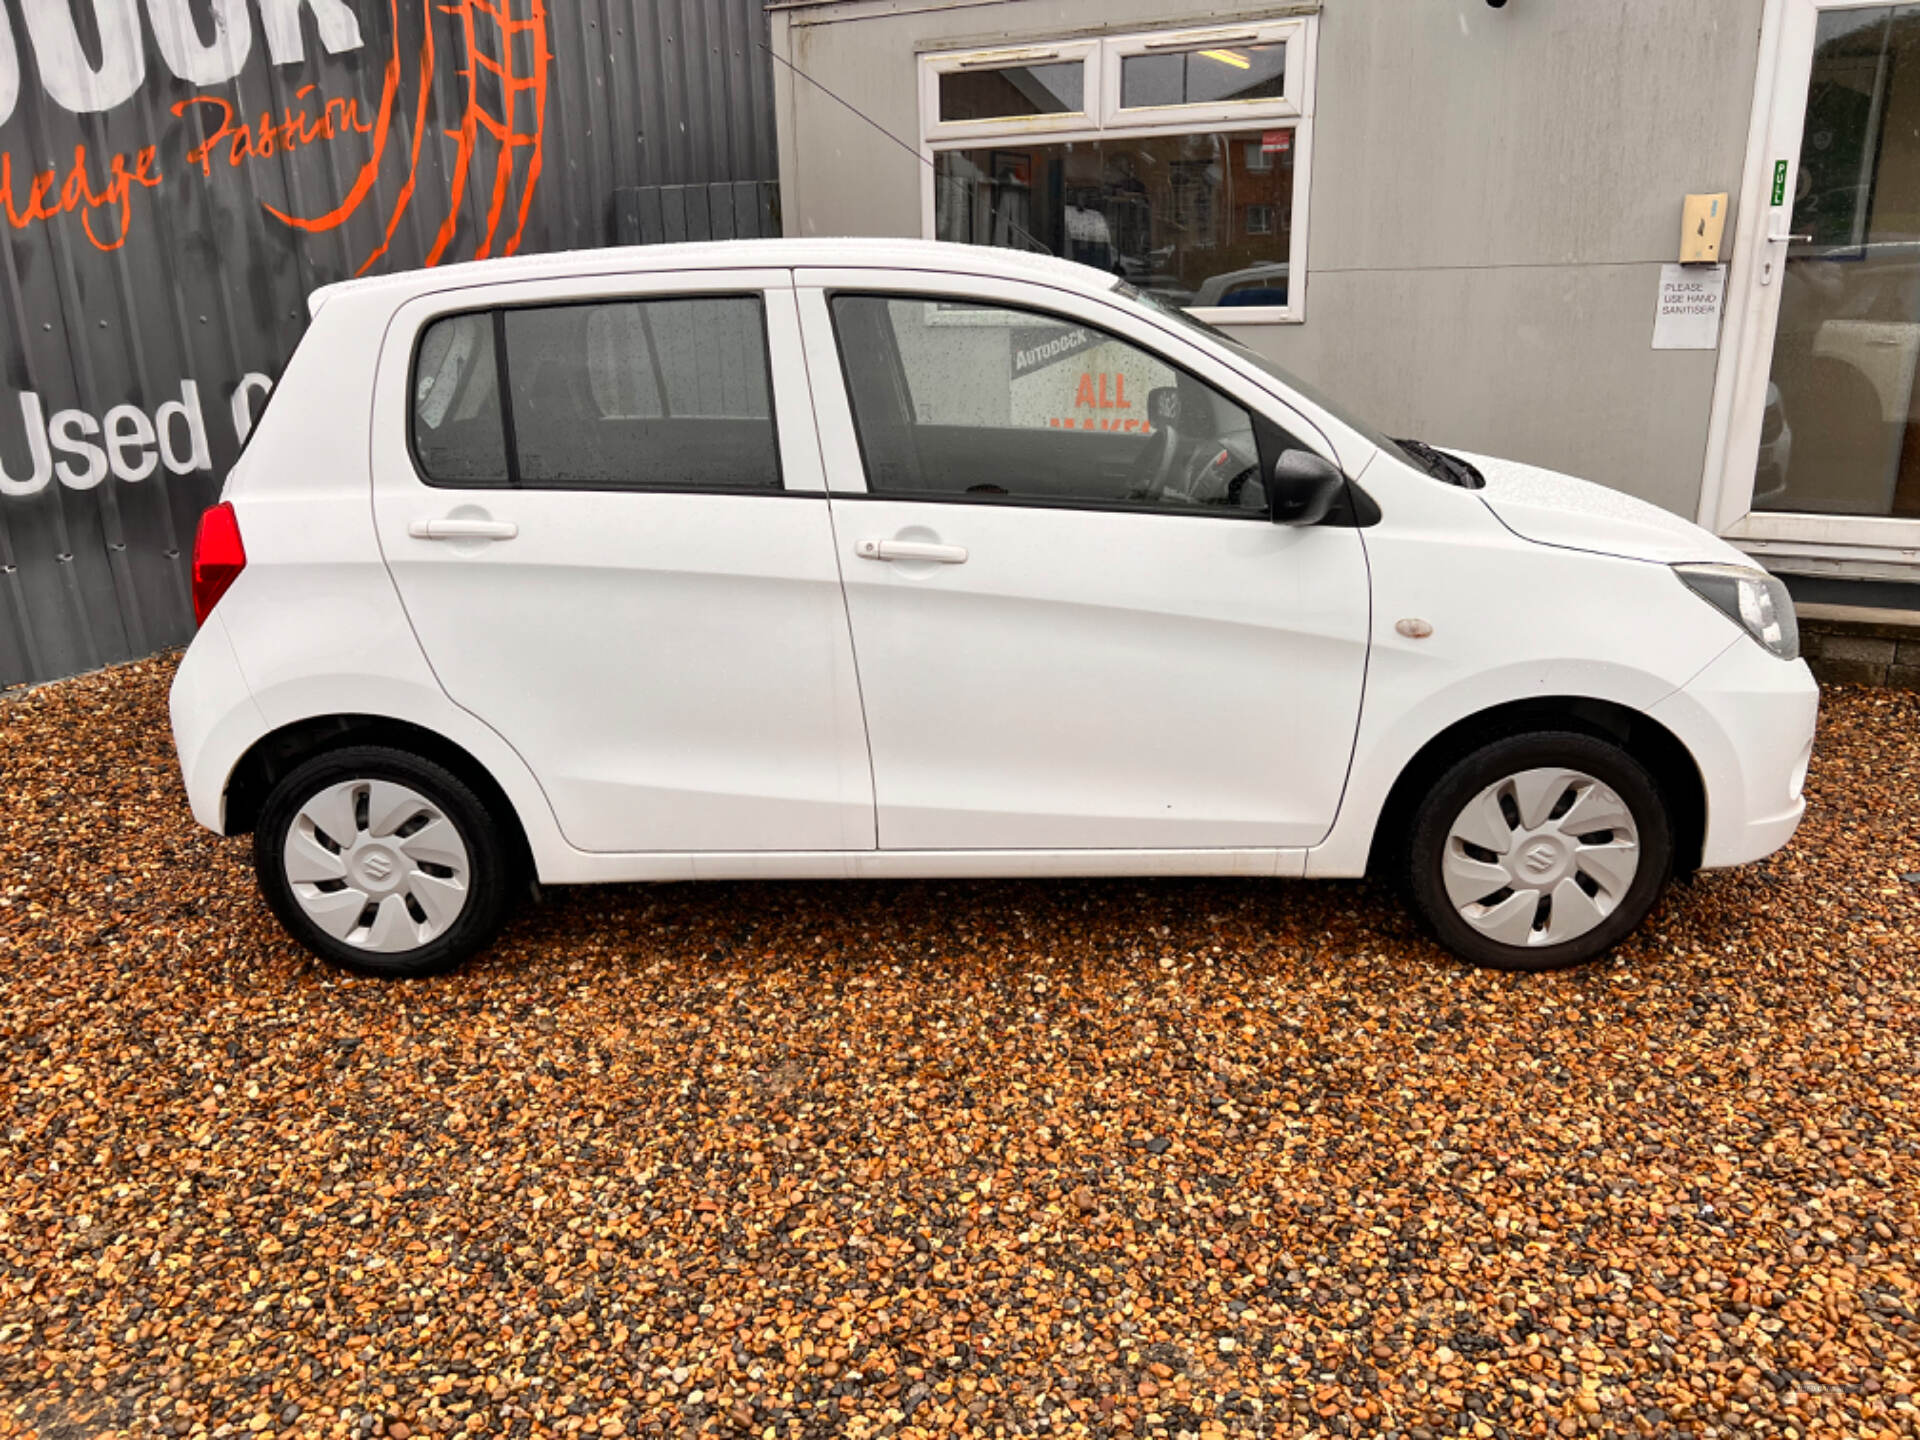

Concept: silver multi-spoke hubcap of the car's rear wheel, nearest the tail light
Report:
left=282, top=780, right=472, bottom=954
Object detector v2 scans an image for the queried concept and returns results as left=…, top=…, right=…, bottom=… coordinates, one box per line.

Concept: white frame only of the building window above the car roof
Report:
left=920, top=15, right=1319, bottom=326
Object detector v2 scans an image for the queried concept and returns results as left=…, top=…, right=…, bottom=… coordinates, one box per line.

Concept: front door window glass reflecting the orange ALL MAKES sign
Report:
left=833, top=294, right=1267, bottom=516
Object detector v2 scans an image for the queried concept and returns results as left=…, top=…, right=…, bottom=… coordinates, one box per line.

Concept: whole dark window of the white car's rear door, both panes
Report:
left=413, top=296, right=781, bottom=492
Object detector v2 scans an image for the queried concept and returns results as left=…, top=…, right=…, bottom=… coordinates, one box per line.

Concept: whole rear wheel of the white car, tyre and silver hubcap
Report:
left=253, top=745, right=513, bottom=975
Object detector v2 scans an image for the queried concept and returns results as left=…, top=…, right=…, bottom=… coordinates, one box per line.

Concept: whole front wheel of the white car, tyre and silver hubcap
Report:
left=1407, top=732, right=1672, bottom=970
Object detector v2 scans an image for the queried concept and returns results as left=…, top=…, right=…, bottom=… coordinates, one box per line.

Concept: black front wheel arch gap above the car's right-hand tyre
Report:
left=1367, top=695, right=1707, bottom=877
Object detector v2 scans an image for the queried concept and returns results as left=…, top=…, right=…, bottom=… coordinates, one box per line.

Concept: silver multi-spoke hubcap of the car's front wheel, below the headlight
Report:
left=1440, top=768, right=1640, bottom=947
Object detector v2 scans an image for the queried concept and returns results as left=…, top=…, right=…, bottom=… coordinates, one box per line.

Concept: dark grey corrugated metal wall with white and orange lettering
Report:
left=0, top=0, right=778, bottom=685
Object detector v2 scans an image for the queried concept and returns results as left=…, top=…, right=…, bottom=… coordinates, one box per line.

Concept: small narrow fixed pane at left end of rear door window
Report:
left=413, top=313, right=507, bottom=490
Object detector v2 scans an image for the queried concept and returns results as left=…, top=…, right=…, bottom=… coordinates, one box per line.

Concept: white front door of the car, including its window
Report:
left=797, top=271, right=1369, bottom=851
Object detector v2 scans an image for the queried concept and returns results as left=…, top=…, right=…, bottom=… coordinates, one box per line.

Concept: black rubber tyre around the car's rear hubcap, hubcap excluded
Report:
left=253, top=745, right=518, bottom=977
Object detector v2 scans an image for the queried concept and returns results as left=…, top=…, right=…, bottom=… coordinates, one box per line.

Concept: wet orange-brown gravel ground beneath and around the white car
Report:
left=0, top=660, right=1920, bottom=1440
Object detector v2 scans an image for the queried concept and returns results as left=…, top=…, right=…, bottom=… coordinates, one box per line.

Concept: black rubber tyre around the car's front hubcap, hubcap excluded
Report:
left=1405, top=732, right=1674, bottom=972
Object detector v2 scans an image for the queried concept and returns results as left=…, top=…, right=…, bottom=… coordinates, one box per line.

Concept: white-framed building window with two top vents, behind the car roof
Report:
left=922, top=15, right=1317, bottom=323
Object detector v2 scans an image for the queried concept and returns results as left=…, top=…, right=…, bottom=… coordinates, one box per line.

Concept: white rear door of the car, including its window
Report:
left=374, top=271, right=874, bottom=852
